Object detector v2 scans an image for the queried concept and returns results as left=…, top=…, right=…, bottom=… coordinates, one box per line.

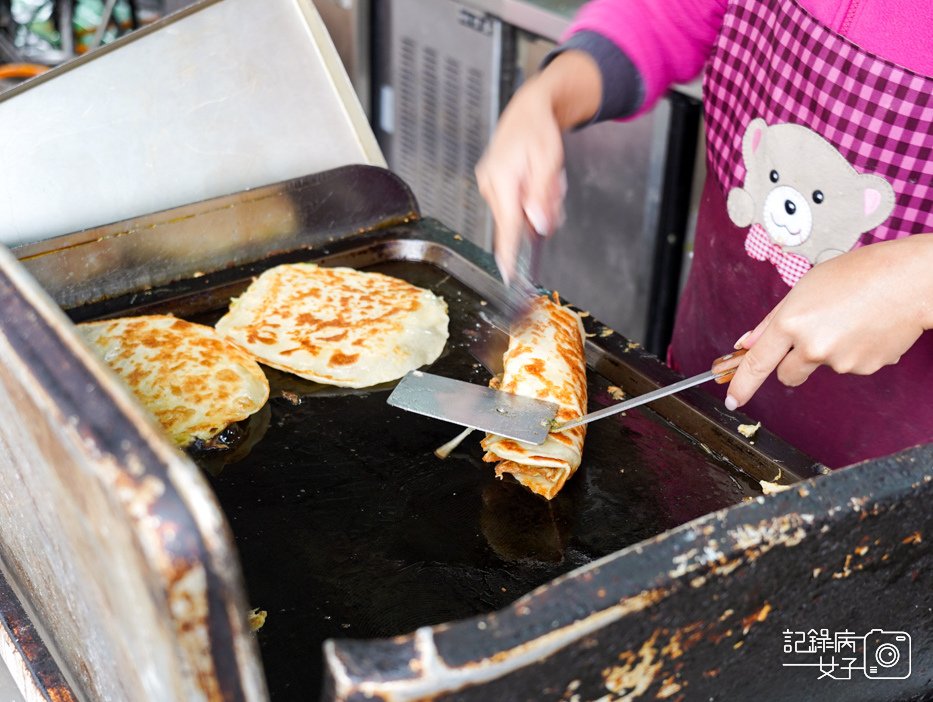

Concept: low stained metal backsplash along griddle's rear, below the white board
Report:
left=15, top=165, right=420, bottom=314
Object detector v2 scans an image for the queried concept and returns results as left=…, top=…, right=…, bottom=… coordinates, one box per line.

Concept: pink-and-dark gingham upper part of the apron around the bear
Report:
left=704, top=0, right=933, bottom=244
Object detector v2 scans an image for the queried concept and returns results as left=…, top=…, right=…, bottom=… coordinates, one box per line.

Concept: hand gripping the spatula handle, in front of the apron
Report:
left=726, top=234, right=933, bottom=409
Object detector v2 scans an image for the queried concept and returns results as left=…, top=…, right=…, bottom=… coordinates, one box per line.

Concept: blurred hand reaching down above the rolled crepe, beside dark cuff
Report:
left=476, top=50, right=602, bottom=282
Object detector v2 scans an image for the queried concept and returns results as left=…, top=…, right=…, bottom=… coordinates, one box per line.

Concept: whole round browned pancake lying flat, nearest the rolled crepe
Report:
left=216, top=263, right=448, bottom=388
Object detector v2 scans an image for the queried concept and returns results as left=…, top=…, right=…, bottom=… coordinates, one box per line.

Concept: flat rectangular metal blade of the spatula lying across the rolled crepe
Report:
left=388, top=371, right=557, bottom=444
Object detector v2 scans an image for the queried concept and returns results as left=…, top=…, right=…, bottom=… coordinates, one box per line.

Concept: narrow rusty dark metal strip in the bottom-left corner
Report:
left=0, top=572, right=78, bottom=702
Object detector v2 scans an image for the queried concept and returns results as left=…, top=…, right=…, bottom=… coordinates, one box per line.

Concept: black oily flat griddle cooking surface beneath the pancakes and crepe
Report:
left=63, top=220, right=816, bottom=699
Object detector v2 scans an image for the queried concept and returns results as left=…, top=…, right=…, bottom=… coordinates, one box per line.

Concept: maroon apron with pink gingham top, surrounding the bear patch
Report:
left=670, top=0, right=933, bottom=468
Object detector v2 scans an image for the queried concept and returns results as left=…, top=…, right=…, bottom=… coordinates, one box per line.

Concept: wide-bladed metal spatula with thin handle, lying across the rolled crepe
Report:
left=388, top=349, right=745, bottom=444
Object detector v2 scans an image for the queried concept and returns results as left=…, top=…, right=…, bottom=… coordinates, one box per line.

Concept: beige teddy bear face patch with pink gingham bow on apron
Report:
left=727, top=119, right=894, bottom=287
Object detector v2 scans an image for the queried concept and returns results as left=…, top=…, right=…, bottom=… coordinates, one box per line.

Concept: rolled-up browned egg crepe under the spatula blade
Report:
left=481, top=296, right=586, bottom=500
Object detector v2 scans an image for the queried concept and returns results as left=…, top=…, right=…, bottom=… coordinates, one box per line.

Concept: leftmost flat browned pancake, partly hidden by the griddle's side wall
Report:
left=78, top=315, right=269, bottom=446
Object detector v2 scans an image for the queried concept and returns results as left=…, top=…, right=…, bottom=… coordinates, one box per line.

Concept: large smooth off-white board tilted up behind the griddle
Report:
left=0, top=0, right=385, bottom=245
